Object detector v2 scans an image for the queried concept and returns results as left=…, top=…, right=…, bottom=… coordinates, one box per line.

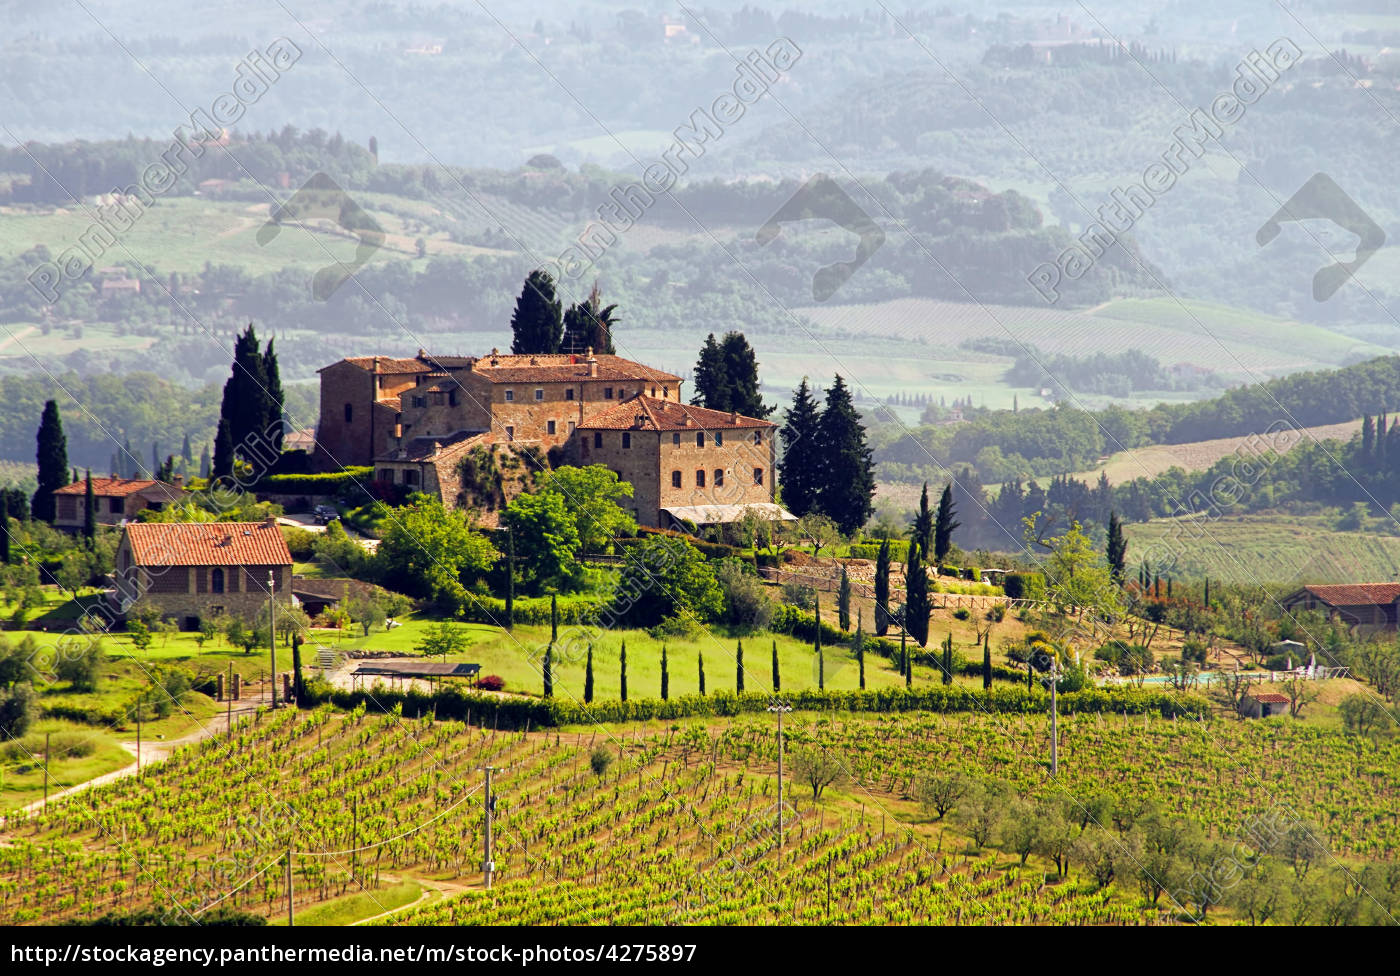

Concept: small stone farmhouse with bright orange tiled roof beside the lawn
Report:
left=113, top=518, right=291, bottom=630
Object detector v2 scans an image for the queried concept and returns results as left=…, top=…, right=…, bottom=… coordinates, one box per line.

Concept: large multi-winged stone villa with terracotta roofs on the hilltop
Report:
left=315, top=350, right=790, bottom=527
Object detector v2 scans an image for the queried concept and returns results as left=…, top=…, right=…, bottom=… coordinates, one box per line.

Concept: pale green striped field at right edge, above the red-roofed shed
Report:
left=1123, top=514, right=1400, bottom=587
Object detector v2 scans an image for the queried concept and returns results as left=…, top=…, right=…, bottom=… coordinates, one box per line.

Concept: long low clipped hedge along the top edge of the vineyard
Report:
left=307, top=685, right=1210, bottom=730
